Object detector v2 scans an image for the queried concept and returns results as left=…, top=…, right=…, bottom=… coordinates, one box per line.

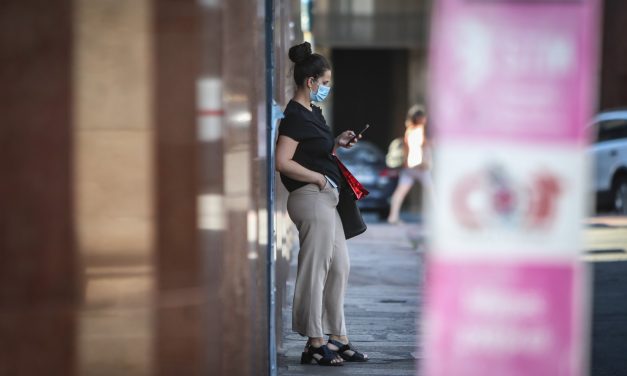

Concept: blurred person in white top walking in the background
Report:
left=388, top=105, right=433, bottom=224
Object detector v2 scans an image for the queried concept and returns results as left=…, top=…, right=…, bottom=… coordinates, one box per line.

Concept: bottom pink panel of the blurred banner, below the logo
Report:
left=424, top=262, right=583, bottom=376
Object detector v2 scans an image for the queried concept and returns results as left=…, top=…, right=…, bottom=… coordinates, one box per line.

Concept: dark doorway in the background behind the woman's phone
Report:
left=331, top=49, right=408, bottom=153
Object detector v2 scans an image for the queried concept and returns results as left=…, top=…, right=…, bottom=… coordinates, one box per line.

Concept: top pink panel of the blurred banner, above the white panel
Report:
left=430, top=0, right=597, bottom=143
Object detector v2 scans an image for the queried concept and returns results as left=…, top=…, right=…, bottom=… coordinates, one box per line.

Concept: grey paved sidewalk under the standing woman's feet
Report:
left=279, top=224, right=423, bottom=376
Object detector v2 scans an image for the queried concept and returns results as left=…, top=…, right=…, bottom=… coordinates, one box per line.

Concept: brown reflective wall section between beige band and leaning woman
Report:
left=153, top=0, right=268, bottom=376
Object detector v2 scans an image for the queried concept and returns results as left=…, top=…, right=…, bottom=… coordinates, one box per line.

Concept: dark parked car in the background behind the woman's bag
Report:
left=337, top=141, right=398, bottom=219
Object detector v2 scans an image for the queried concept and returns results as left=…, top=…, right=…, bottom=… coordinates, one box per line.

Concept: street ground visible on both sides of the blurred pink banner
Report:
left=279, top=216, right=627, bottom=376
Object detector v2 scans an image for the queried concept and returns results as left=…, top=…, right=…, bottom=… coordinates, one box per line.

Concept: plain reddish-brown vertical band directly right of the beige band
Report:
left=153, top=0, right=207, bottom=376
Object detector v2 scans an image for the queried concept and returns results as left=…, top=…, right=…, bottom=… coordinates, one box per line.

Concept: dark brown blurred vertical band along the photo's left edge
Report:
left=0, top=0, right=79, bottom=376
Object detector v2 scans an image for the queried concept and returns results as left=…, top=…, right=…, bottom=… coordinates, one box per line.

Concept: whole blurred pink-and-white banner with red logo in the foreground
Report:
left=423, top=0, right=599, bottom=376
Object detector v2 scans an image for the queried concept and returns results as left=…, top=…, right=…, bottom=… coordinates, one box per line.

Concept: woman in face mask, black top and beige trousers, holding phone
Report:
left=276, top=42, right=368, bottom=366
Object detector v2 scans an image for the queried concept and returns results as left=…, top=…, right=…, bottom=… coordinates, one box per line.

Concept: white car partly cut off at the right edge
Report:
left=590, top=109, right=627, bottom=215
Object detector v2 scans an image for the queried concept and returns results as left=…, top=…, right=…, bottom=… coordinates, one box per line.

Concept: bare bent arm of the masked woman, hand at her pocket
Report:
left=275, top=136, right=327, bottom=189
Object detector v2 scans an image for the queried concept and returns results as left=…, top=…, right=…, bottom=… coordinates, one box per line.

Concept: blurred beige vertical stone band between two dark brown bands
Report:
left=71, top=0, right=156, bottom=375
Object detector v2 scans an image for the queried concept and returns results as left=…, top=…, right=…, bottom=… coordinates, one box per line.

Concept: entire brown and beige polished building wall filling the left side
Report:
left=0, top=0, right=300, bottom=376
